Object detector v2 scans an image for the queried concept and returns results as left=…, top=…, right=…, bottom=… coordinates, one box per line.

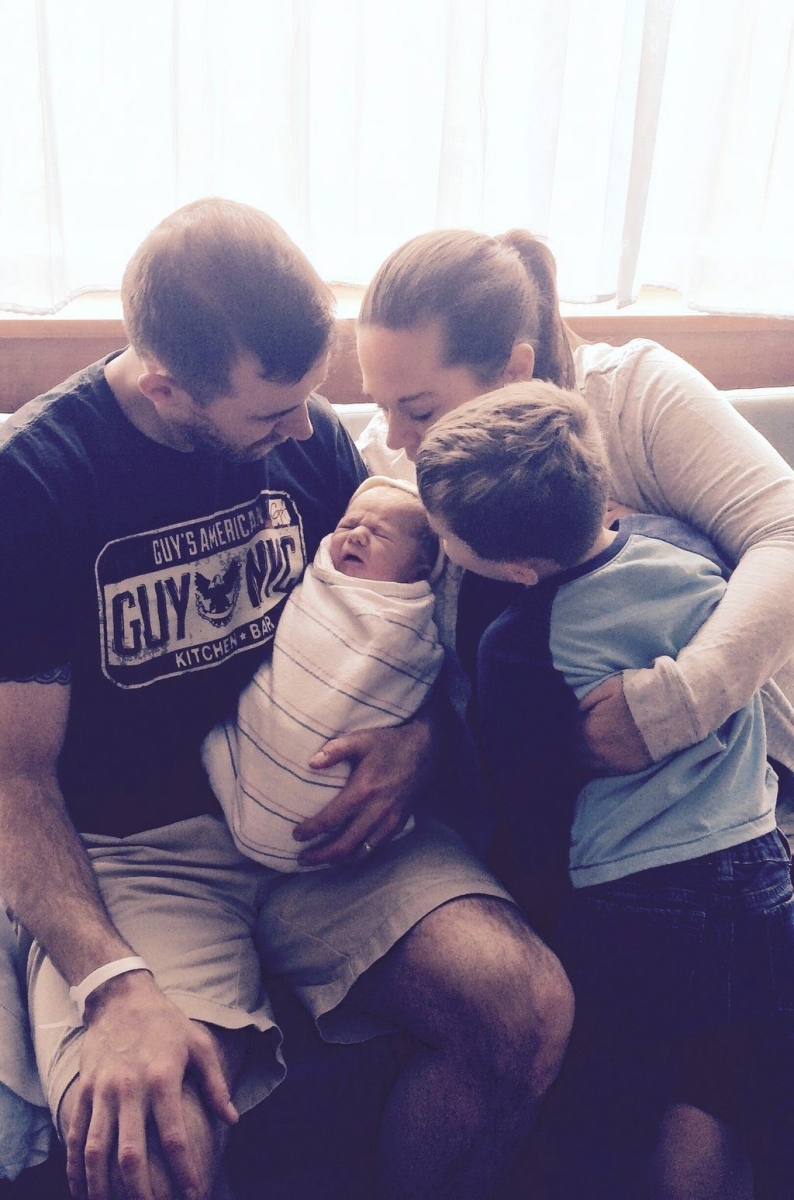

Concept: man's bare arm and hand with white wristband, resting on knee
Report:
left=0, top=677, right=236, bottom=1198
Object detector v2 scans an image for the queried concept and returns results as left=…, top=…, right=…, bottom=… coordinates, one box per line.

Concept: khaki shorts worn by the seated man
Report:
left=28, top=816, right=510, bottom=1117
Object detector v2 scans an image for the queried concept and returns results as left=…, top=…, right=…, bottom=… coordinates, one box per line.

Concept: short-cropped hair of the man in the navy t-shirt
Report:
left=121, top=198, right=335, bottom=403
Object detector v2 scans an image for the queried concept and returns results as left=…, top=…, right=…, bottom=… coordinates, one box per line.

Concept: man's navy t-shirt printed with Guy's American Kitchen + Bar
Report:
left=0, top=360, right=366, bottom=836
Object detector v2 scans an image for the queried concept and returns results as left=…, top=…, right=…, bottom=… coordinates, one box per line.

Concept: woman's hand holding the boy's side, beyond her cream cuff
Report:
left=579, top=674, right=652, bottom=775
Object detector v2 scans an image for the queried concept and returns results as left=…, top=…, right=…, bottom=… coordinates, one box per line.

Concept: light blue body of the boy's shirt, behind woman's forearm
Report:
left=549, top=521, right=777, bottom=887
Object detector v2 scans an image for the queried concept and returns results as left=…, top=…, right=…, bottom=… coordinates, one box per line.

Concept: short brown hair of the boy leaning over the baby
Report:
left=416, top=379, right=608, bottom=566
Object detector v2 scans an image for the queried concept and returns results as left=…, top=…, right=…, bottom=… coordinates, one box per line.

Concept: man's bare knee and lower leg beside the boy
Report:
left=350, top=896, right=573, bottom=1200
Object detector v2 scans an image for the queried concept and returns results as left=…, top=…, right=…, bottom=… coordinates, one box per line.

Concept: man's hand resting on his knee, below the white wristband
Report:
left=65, top=972, right=237, bottom=1200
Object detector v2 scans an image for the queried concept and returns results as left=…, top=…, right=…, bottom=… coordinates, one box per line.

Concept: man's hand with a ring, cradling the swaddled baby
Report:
left=295, top=714, right=433, bottom=866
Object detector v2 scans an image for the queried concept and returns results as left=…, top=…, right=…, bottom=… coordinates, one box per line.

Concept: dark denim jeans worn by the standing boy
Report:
left=534, top=832, right=794, bottom=1200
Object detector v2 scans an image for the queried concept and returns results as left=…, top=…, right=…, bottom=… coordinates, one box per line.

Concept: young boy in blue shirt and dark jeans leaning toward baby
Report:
left=416, top=382, right=794, bottom=1200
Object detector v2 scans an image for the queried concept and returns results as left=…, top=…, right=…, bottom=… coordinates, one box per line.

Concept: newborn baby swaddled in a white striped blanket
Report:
left=203, top=476, right=444, bottom=871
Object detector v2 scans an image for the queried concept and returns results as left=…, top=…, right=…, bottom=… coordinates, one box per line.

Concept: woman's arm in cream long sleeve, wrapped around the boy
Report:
left=583, top=343, right=794, bottom=769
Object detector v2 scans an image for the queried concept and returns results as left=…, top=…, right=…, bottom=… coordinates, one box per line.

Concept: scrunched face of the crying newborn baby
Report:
left=331, top=486, right=426, bottom=583
